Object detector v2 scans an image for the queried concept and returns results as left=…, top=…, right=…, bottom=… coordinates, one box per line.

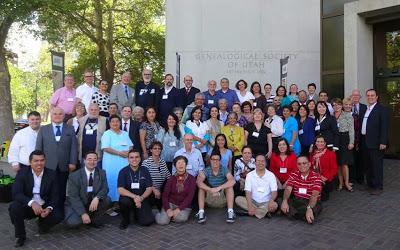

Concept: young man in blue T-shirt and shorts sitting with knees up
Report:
left=196, top=151, right=236, bottom=224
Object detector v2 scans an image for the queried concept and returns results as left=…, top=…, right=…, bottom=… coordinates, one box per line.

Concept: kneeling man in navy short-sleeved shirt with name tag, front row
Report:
left=118, top=149, right=154, bottom=230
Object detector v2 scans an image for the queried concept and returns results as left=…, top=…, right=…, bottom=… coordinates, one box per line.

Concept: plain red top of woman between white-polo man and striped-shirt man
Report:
left=269, top=152, right=297, bottom=185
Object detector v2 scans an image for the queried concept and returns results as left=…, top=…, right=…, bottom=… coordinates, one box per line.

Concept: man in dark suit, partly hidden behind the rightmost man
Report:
left=350, top=89, right=367, bottom=184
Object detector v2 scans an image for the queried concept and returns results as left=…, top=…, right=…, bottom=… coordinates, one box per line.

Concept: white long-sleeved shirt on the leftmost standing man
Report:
left=8, top=127, right=38, bottom=166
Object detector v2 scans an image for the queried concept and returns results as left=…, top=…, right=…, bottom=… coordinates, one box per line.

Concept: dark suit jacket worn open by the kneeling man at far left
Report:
left=12, top=167, right=58, bottom=208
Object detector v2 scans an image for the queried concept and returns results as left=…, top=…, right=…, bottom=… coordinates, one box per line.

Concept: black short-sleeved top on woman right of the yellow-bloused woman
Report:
left=245, top=123, right=271, bottom=155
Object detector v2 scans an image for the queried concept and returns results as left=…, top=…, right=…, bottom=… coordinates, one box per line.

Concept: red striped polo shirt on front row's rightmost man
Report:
left=286, top=170, right=322, bottom=200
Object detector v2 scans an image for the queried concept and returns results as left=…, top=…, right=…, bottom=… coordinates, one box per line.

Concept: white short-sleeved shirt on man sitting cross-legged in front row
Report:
left=244, top=169, right=278, bottom=203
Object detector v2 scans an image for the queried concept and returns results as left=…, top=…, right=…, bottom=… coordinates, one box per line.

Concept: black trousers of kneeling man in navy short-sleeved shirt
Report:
left=119, top=196, right=154, bottom=226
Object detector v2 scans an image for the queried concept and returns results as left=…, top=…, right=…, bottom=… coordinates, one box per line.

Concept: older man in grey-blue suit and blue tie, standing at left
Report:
left=36, top=108, right=78, bottom=210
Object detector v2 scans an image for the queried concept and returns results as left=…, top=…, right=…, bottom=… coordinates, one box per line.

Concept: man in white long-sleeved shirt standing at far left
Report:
left=8, top=111, right=41, bottom=172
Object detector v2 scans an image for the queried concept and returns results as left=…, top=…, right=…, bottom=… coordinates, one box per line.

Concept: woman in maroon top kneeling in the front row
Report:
left=156, top=156, right=196, bottom=225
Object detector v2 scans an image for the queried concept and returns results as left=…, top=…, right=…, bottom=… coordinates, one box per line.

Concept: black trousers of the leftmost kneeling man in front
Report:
left=8, top=201, right=63, bottom=238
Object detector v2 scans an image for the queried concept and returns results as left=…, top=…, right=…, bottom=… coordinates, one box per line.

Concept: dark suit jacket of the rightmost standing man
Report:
left=360, top=103, right=389, bottom=149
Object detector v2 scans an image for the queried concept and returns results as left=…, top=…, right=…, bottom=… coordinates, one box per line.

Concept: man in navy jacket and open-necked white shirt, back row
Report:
left=157, top=74, right=182, bottom=125
